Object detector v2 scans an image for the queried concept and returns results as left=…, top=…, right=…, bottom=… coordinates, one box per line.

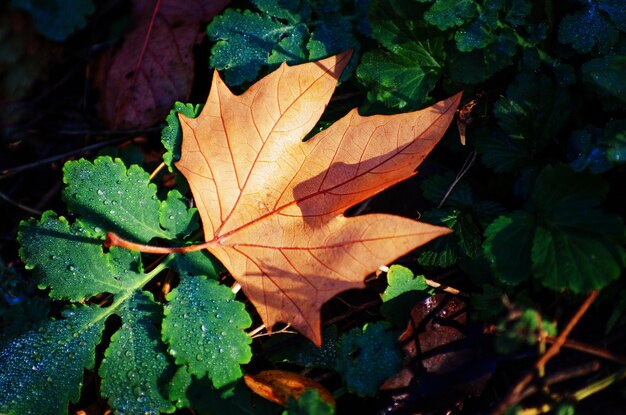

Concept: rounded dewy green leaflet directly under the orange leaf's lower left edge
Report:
left=163, top=276, right=252, bottom=388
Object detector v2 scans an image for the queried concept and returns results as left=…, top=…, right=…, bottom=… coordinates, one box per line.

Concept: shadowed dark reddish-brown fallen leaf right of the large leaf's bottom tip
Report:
left=381, top=294, right=494, bottom=414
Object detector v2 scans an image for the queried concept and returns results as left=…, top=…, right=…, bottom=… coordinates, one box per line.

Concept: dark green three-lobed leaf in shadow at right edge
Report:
left=484, top=165, right=624, bottom=292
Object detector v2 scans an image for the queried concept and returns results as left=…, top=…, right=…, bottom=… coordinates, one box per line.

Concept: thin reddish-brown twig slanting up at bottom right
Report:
left=492, top=290, right=599, bottom=415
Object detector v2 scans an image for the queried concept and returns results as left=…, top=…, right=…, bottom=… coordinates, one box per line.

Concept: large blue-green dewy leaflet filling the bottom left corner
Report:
left=0, top=306, right=106, bottom=415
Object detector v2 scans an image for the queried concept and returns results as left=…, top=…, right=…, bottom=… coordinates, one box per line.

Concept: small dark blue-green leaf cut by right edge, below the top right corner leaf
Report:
left=581, top=55, right=626, bottom=101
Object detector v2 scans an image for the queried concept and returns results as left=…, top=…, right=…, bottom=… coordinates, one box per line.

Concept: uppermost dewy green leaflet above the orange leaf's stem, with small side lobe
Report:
left=63, top=157, right=193, bottom=242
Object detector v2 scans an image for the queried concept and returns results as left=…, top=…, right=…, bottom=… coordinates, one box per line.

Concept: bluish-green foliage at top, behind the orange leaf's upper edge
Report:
left=207, top=0, right=362, bottom=86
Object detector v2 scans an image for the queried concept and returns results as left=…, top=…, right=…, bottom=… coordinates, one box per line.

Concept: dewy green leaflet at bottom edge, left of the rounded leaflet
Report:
left=98, top=292, right=175, bottom=414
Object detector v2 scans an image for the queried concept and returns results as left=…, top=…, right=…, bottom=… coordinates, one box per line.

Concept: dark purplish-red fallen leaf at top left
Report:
left=95, top=0, right=228, bottom=128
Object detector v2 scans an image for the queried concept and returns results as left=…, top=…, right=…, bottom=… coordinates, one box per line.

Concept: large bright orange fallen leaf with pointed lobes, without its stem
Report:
left=176, top=52, right=461, bottom=345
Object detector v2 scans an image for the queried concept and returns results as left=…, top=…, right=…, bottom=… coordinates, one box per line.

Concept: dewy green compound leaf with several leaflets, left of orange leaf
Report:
left=0, top=157, right=251, bottom=413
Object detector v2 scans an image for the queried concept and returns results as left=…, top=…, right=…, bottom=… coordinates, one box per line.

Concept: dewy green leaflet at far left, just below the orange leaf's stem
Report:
left=19, top=211, right=142, bottom=301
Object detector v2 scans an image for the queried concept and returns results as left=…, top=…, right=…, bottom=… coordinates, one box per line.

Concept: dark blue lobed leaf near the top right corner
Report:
left=559, top=2, right=619, bottom=53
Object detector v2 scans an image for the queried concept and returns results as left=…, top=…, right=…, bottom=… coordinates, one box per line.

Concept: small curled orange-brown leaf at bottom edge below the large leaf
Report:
left=243, top=370, right=335, bottom=406
